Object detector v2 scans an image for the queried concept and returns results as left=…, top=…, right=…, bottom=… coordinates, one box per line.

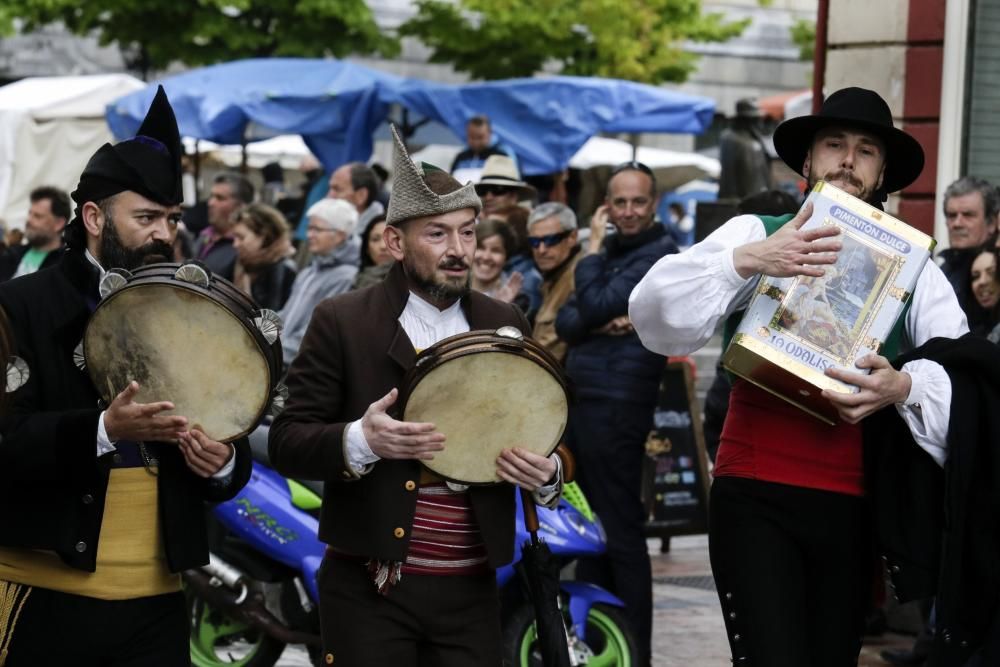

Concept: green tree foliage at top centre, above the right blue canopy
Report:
left=399, top=0, right=750, bottom=83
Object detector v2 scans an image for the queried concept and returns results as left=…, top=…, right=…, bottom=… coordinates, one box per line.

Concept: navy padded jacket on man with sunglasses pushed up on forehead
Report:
left=556, top=222, right=677, bottom=406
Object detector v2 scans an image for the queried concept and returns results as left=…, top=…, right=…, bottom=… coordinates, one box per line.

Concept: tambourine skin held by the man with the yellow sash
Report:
left=84, top=283, right=273, bottom=442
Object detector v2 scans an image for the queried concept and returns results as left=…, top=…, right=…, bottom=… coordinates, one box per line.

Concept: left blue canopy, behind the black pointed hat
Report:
left=107, top=58, right=402, bottom=170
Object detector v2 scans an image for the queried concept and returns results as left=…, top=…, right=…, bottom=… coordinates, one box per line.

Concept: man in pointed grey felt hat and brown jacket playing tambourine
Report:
left=269, top=128, right=561, bottom=667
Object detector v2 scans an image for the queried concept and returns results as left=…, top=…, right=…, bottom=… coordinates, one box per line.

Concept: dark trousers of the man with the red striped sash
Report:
left=317, top=557, right=501, bottom=667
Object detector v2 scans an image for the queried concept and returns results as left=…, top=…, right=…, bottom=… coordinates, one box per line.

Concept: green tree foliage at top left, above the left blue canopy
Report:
left=0, top=0, right=399, bottom=73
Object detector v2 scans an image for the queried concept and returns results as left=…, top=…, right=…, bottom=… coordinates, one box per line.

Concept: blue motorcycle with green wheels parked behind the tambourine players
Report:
left=184, top=427, right=636, bottom=667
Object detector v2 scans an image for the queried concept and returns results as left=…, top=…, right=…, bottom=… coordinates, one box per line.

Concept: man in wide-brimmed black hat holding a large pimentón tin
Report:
left=629, top=88, right=968, bottom=667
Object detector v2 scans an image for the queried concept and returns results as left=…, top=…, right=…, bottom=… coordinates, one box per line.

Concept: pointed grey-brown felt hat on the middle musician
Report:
left=386, top=125, right=483, bottom=225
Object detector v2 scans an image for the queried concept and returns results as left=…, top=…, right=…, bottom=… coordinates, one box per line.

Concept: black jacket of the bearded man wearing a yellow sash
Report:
left=0, top=251, right=250, bottom=572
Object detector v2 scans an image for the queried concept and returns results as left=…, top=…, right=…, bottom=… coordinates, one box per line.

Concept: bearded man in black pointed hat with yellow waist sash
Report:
left=0, top=88, right=250, bottom=667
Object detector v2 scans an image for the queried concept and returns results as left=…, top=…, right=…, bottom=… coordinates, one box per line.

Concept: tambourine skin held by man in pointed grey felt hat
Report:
left=403, top=332, right=569, bottom=484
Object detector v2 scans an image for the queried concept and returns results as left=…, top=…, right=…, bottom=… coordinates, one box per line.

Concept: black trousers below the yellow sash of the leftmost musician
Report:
left=5, top=588, right=191, bottom=667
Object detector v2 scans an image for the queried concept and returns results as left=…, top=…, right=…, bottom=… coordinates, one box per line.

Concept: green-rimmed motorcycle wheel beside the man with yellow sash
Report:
left=188, top=596, right=285, bottom=667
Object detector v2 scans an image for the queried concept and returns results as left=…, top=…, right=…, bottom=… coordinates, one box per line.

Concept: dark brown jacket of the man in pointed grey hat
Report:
left=268, top=264, right=529, bottom=568
